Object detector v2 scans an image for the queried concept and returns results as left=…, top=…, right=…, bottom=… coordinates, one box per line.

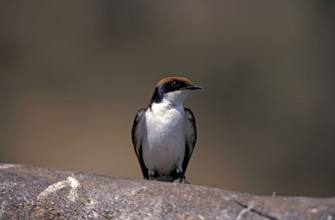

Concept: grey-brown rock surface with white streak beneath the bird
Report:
left=0, top=164, right=335, bottom=220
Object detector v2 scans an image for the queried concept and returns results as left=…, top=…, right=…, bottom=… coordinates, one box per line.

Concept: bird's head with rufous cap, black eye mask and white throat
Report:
left=151, top=77, right=202, bottom=105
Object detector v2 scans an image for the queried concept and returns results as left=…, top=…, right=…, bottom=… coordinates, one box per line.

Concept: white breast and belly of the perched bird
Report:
left=143, top=105, right=185, bottom=175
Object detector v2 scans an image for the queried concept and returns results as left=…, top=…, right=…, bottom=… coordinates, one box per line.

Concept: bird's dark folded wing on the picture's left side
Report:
left=131, top=108, right=149, bottom=179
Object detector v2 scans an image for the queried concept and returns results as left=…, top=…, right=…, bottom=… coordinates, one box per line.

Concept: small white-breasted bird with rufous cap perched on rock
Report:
left=131, top=76, right=202, bottom=183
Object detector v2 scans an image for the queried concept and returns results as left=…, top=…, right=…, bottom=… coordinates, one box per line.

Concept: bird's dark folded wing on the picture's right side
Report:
left=182, top=108, right=197, bottom=174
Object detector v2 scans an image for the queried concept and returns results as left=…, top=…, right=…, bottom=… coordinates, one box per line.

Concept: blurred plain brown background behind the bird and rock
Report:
left=0, top=0, right=335, bottom=197
